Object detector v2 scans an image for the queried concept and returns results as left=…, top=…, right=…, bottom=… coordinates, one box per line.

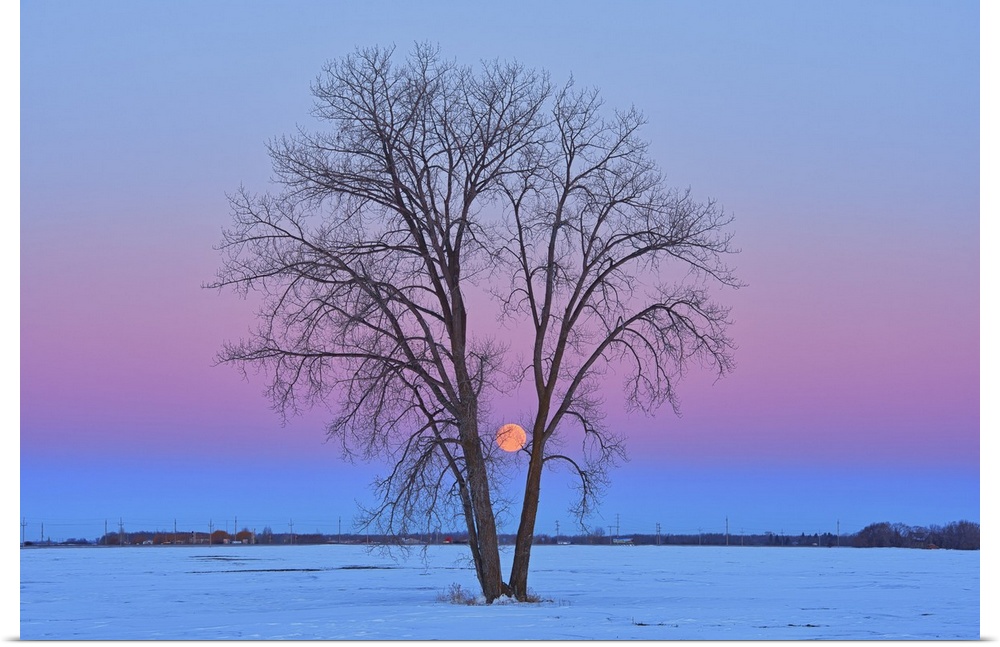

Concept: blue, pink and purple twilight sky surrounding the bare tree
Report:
left=19, top=0, right=980, bottom=539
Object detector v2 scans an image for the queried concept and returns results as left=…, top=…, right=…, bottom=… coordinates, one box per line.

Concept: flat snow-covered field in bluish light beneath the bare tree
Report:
left=20, top=545, right=980, bottom=640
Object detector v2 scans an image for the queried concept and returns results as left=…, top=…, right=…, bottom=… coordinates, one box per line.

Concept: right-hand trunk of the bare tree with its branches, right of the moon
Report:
left=498, top=83, right=739, bottom=599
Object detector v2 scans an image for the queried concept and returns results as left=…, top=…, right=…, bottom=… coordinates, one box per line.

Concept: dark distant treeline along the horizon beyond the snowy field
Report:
left=24, top=521, right=979, bottom=550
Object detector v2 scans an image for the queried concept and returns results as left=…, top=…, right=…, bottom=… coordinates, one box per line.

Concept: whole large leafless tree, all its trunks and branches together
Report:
left=212, top=45, right=737, bottom=602
